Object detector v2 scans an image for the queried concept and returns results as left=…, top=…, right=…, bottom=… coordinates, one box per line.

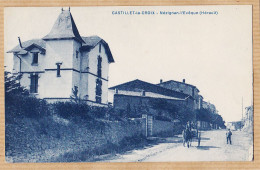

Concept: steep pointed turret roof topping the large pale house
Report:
left=43, top=10, right=84, bottom=43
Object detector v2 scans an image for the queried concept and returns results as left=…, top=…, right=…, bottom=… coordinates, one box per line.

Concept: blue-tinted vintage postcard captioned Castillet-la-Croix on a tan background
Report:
left=4, top=5, right=254, bottom=163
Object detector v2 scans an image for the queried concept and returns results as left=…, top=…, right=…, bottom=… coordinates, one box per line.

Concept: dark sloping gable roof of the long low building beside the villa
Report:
left=109, top=79, right=192, bottom=99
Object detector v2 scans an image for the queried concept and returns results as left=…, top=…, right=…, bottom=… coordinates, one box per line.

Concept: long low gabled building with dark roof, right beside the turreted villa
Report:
left=109, top=79, right=195, bottom=117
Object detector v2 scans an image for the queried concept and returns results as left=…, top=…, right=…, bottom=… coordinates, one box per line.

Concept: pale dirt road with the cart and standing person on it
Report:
left=102, top=130, right=253, bottom=162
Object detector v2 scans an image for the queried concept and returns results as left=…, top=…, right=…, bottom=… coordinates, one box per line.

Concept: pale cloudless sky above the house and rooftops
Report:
left=4, top=5, right=253, bottom=122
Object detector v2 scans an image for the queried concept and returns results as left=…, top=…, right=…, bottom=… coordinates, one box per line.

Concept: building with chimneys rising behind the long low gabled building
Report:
left=157, top=79, right=203, bottom=109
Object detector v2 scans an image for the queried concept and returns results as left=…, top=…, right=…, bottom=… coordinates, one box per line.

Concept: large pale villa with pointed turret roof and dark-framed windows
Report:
left=8, top=9, right=114, bottom=105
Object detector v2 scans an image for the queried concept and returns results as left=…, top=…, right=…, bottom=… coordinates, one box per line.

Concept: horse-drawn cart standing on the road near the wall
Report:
left=182, top=128, right=201, bottom=148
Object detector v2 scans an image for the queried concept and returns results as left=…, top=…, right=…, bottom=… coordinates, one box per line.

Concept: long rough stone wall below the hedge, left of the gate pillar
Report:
left=6, top=116, right=145, bottom=162
